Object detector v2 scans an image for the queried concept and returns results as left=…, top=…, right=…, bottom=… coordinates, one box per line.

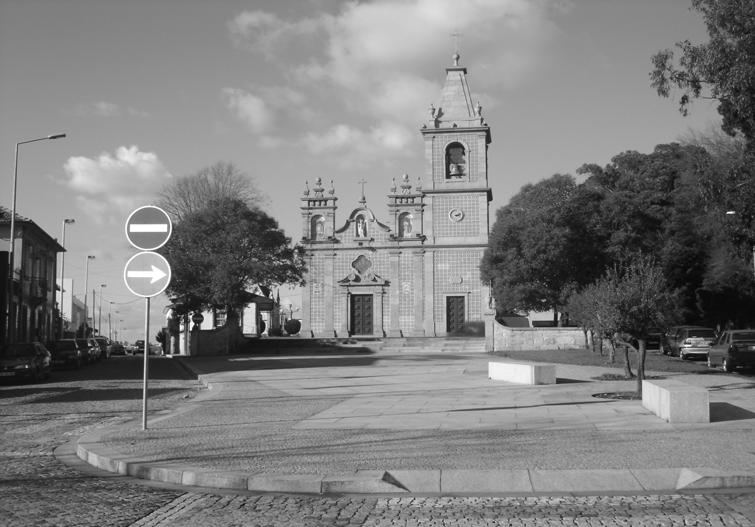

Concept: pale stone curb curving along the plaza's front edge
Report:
left=76, top=433, right=755, bottom=495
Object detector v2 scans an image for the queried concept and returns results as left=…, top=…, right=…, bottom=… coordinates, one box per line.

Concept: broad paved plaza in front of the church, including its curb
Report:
left=72, top=348, right=755, bottom=495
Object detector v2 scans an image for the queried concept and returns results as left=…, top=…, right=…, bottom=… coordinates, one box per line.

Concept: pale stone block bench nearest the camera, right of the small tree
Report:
left=642, top=379, right=710, bottom=423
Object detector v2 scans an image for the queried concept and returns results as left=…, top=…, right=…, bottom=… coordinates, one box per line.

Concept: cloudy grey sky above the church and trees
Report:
left=0, top=0, right=720, bottom=341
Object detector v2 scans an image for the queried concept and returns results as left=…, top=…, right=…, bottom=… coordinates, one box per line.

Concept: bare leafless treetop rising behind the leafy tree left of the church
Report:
left=160, top=161, right=266, bottom=223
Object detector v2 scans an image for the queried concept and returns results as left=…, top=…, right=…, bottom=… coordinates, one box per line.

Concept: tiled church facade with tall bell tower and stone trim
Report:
left=301, top=54, right=492, bottom=337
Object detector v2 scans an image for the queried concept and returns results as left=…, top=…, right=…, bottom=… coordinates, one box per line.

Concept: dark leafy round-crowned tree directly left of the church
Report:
left=160, top=198, right=304, bottom=350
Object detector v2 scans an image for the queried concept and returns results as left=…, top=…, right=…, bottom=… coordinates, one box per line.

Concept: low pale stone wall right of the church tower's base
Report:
left=485, top=316, right=585, bottom=351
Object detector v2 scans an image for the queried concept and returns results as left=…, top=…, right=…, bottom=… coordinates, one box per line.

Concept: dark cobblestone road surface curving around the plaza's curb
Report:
left=0, top=357, right=755, bottom=527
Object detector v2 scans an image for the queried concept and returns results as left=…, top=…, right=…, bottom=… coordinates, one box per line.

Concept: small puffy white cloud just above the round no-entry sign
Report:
left=63, top=146, right=172, bottom=219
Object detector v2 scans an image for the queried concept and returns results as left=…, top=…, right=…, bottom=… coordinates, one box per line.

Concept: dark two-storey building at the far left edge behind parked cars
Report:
left=0, top=207, right=65, bottom=342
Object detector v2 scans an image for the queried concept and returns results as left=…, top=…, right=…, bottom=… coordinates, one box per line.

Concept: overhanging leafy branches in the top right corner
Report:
left=650, top=0, right=755, bottom=147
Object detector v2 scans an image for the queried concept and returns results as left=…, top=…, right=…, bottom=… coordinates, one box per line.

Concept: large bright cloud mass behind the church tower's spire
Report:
left=229, top=0, right=570, bottom=158
